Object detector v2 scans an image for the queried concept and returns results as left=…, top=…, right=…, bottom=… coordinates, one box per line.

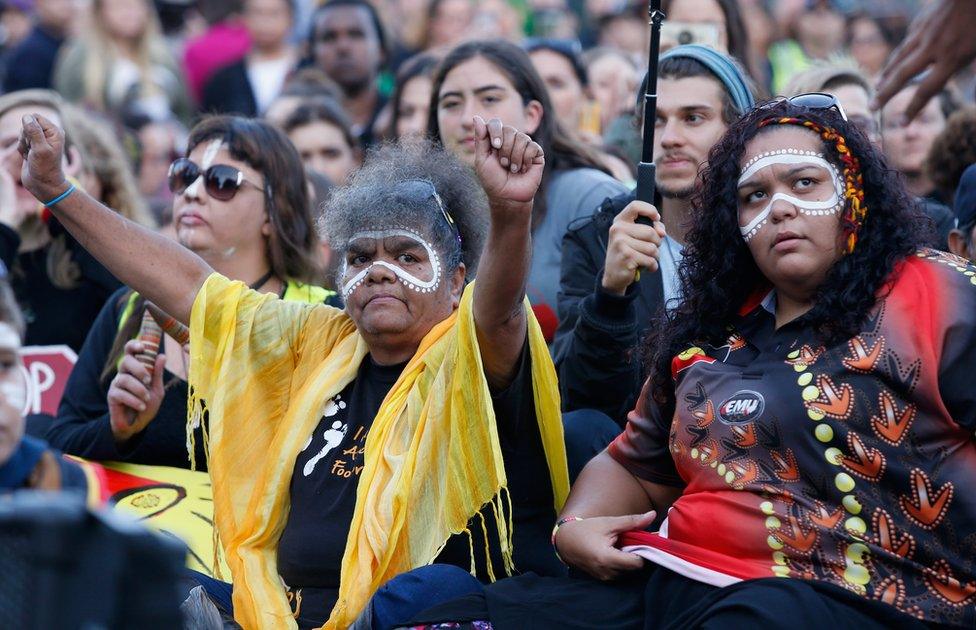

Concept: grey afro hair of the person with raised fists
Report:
left=319, top=141, right=488, bottom=279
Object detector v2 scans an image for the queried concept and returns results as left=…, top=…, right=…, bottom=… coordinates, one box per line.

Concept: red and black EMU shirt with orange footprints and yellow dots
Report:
left=610, top=250, right=976, bottom=627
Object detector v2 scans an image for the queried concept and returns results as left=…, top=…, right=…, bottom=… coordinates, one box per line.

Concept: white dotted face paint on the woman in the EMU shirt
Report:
left=738, top=149, right=844, bottom=243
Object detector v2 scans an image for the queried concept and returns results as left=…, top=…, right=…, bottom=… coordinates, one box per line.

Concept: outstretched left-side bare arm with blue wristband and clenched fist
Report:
left=18, top=115, right=213, bottom=323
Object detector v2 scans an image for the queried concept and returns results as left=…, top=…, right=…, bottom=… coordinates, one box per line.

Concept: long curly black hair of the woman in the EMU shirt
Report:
left=644, top=101, right=932, bottom=404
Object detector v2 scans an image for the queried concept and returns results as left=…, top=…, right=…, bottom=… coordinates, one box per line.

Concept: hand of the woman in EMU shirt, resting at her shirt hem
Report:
left=554, top=510, right=655, bottom=580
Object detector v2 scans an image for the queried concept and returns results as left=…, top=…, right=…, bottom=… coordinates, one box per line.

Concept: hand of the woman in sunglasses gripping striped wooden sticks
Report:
left=108, top=340, right=166, bottom=442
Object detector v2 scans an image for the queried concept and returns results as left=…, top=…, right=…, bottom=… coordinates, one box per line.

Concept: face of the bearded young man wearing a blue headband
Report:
left=645, top=77, right=728, bottom=199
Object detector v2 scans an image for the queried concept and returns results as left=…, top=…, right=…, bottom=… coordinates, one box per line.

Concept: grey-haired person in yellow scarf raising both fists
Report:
left=20, top=117, right=568, bottom=628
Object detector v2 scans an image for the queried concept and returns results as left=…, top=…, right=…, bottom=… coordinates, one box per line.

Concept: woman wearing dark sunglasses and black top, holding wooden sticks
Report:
left=48, top=116, right=337, bottom=468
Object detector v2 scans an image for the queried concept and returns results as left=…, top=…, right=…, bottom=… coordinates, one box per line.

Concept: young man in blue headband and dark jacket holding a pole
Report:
left=553, top=45, right=753, bottom=472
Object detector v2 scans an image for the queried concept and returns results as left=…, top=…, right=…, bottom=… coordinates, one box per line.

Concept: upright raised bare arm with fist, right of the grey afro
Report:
left=474, top=117, right=545, bottom=387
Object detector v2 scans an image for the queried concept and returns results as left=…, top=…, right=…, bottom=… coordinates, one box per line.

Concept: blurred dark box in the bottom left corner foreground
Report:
left=0, top=491, right=186, bottom=630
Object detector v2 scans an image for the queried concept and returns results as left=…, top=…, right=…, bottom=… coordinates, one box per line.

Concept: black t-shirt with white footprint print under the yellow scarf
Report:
left=278, top=349, right=562, bottom=628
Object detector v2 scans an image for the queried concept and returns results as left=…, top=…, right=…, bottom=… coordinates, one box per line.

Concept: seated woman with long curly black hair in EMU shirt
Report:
left=400, top=95, right=976, bottom=629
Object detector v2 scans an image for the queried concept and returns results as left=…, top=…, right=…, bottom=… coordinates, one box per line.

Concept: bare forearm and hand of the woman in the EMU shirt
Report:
left=555, top=451, right=681, bottom=580
